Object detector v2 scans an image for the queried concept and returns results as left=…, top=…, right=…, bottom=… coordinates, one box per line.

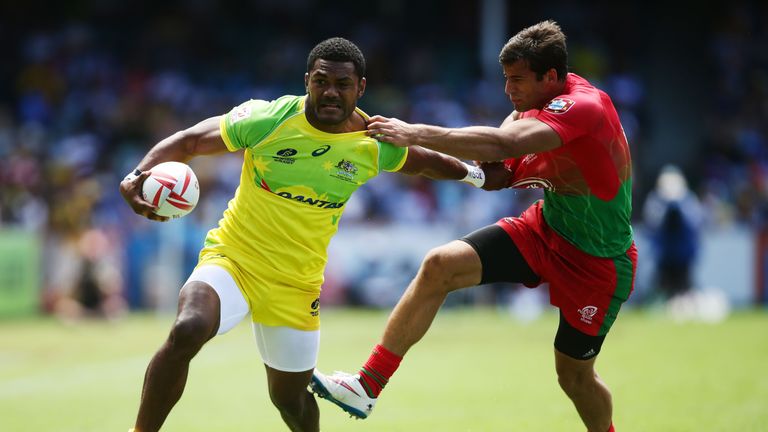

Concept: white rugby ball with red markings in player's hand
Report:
left=142, top=162, right=200, bottom=218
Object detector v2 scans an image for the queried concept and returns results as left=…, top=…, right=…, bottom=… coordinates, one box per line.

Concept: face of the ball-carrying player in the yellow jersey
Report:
left=304, top=59, right=365, bottom=127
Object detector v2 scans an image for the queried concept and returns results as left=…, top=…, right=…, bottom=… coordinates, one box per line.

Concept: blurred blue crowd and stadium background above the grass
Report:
left=0, top=0, right=768, bottom=319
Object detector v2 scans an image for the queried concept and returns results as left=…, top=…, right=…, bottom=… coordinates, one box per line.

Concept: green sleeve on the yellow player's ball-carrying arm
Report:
left=219, top=96, right=300, bottom=151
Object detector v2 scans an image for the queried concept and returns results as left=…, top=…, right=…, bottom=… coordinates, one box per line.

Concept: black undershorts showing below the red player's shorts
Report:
left=459, top=225, right=605, bottom=360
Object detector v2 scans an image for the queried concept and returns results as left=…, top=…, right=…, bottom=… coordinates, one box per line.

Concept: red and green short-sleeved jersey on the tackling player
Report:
left=505, top=73, right=632, bottom=257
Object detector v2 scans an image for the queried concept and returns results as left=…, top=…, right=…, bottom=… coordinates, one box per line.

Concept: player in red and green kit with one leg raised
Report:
left=312, top=21, right=637, bottom=432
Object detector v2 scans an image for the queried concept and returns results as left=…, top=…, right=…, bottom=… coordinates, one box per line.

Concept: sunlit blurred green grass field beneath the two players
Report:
left=0, top=310, right=768, bottom=432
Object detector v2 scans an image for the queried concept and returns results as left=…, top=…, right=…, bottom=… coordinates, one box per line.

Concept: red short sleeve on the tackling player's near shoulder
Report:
left=536, top=95, right=603, bottom=145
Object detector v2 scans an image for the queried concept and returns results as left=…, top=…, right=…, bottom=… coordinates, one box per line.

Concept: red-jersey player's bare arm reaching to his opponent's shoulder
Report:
left=368, top=113, right=562, bottom=161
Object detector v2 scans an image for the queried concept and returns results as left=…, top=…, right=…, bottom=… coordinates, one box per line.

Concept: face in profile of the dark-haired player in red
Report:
left=502, top=60, right=557, bottom=112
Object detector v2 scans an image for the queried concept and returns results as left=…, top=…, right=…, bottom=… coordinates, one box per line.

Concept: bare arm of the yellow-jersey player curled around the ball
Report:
left=120, top=117, right=227, bottom=221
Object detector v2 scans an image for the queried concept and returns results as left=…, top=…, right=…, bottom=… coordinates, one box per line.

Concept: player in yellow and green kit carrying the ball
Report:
left=120, top=38, right=484, bottom=432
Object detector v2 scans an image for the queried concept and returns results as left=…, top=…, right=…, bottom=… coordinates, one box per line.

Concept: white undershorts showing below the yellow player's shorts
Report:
left=182, top=265, right=320, bottom=372
